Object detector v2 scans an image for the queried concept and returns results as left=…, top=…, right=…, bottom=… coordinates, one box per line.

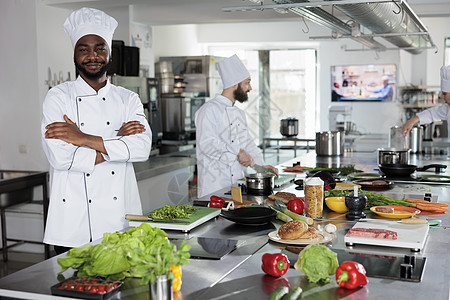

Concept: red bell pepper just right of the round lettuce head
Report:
left=336, top=261, right=369, bottom=290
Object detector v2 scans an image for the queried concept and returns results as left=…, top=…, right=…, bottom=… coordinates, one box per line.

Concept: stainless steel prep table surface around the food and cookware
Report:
left=0, top=152, right=450, bottom=299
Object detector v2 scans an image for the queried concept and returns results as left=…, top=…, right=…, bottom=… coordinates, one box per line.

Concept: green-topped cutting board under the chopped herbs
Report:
left=129, top=206, right=221, bottom=232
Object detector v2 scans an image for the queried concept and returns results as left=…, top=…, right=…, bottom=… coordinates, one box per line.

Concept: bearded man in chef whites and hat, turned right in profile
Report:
left=195, top=55, right=278, bottom=198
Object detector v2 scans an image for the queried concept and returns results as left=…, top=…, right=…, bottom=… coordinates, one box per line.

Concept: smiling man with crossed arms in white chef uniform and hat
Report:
left=41, top=8, right=152, bottom=254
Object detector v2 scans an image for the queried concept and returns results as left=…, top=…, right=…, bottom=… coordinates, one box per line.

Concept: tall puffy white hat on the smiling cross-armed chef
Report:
left=64, top=7, right=118, bottom=52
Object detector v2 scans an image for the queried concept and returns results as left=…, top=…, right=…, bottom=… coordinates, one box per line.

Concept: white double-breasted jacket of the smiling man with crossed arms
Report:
left=41, top=77, right=152, bottom=247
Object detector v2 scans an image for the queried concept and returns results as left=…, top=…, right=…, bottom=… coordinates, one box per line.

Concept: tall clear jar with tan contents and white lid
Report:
left=305, top=177, right=324, bottom=219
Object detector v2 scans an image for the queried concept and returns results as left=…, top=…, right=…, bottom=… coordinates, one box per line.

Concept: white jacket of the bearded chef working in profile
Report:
left=195, top=95, right=264, bottom=197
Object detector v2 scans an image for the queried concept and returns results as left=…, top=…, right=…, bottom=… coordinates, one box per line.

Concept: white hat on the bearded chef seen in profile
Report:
left=217, top=54, right=250, bottom=89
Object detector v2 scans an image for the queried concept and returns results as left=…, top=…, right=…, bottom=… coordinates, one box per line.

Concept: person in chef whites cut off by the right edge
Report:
left=402, top=66, right=450, bottom=136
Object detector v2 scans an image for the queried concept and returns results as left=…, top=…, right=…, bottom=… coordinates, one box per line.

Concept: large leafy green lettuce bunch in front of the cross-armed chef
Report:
left=58, top=223, right=190, bottom=284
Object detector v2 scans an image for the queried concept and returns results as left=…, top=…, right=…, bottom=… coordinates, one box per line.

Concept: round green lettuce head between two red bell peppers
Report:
left=294, top=244, right=339, bottom=283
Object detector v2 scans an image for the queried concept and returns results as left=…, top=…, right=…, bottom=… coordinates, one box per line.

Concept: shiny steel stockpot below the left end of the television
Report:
left=316, top=131, right=344, bottom=156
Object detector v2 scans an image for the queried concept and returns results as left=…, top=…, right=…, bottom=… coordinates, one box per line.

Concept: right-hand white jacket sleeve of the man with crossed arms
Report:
left=103, top=93, right=152, bottom=162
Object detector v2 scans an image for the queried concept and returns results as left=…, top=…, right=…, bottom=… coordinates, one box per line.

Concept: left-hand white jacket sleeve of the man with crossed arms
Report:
left=41, top=89, right=96, bottom=173
